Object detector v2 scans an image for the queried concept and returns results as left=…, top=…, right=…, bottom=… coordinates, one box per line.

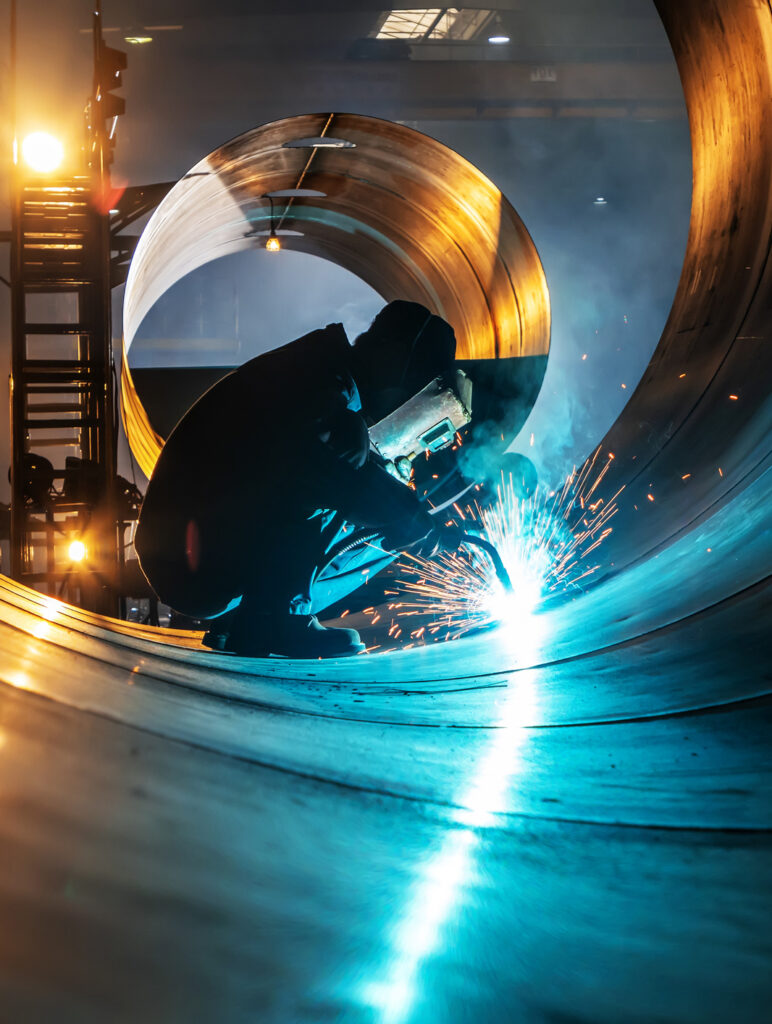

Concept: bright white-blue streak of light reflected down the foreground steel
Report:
left=361, top=626, right=543, bottom=1024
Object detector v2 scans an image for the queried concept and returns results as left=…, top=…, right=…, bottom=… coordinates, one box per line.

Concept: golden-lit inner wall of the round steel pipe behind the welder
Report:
left=123, top=114, right=550, bottom=475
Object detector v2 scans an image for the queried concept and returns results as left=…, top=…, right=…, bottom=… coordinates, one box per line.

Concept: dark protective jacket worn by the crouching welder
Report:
left=135, top=324, right=431, bottom=616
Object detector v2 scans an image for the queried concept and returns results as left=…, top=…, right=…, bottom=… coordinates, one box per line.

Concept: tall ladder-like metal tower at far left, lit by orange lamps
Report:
left=10, top=4, right=126, bottom=614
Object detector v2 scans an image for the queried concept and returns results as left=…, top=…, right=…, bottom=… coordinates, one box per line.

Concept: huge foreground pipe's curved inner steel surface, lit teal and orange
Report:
left=0, top=0, right=772, bottom=1024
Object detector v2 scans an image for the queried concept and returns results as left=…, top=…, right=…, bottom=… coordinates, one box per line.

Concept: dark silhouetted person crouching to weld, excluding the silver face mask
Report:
left=135, top=301, right=459, bottom=657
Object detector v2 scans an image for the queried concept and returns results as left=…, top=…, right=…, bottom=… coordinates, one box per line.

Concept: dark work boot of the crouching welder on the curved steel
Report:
left=225, top=614, right=364, bottom=657
